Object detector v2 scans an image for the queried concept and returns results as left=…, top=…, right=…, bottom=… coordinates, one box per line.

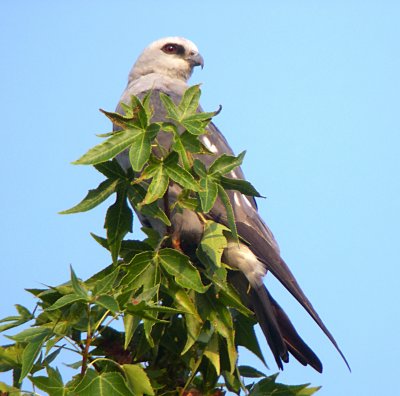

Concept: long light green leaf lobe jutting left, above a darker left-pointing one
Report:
left=73, top=129, right=141, bottom=165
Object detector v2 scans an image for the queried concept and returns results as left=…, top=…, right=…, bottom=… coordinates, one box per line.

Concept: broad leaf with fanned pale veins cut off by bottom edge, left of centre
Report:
left=74, top=370, right=135, bottom=396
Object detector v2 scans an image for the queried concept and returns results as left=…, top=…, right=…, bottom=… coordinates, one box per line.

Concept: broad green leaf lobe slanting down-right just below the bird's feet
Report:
left=158, top=248, right=207, bottom=293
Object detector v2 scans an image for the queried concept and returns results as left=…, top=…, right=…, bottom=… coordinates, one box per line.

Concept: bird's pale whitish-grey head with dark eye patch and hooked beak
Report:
left=129, top=37, right=204, bottom=82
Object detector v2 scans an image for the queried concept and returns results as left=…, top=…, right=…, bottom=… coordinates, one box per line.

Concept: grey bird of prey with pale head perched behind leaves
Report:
left=114, top=37, right=350, bottom=373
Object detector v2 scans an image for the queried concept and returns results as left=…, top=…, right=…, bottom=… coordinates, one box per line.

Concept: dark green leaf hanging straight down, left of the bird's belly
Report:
left=104, top=191, right=133, bottom=263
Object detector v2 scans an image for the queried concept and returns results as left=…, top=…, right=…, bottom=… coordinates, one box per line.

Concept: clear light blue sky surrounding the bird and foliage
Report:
left=0, top=0, right=400, bottom=396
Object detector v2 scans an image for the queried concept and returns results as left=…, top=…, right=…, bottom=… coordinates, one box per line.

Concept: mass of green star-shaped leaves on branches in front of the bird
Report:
left=0, top=86, right=317, bottom=396
